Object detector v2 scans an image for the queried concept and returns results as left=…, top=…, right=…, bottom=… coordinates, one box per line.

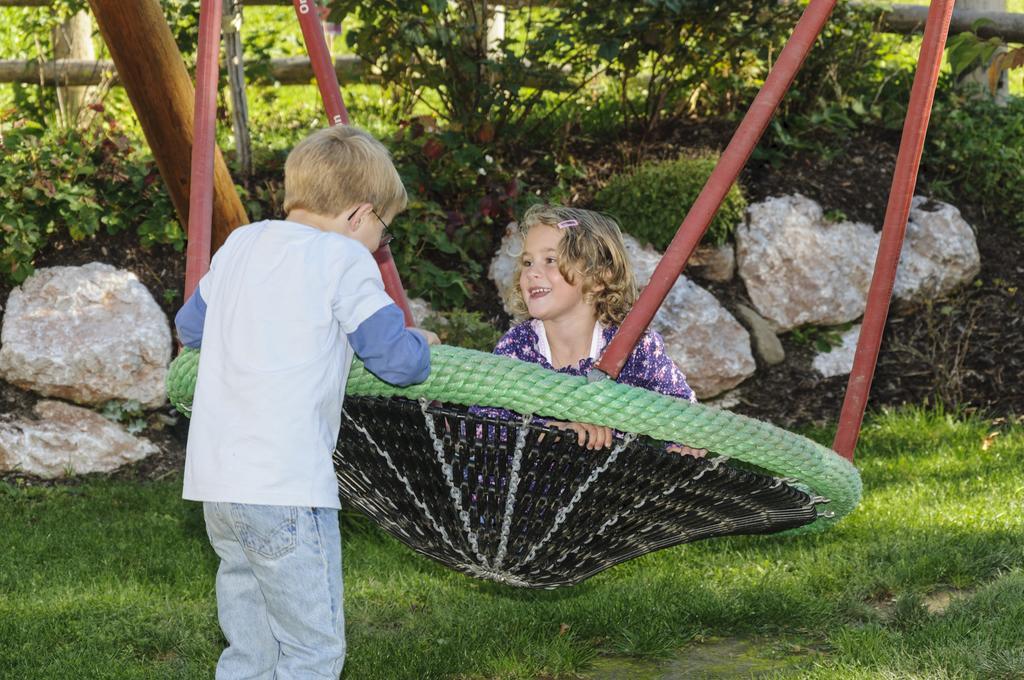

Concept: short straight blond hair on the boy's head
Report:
left=284, top=125, right=409, bottom=217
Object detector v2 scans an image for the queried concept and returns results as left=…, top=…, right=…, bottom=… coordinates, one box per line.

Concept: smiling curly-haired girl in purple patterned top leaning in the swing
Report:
left=479, top=204, right=706, bottom=456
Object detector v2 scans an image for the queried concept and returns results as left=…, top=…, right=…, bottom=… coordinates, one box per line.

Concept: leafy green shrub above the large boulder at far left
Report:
left=0, top=112, right=184, bottom=283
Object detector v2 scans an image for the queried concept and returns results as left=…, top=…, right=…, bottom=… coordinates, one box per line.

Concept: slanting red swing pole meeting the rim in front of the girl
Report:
left=594, top=0, right=836, bottom=379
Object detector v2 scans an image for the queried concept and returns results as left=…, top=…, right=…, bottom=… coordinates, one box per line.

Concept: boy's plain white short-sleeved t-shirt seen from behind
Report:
left=182, top=220, right=391, bottom=508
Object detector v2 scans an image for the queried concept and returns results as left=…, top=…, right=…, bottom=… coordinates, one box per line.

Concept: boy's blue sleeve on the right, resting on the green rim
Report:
left=348, top=303, right=430, bottom=387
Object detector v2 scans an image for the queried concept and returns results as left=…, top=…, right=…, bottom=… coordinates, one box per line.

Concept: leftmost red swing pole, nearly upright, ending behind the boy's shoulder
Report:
left=184, top=0, right=222, bottom=300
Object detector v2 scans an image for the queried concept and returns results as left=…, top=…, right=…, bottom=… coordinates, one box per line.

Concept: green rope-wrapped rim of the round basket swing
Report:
left=167, top=345, right=861, bottom=534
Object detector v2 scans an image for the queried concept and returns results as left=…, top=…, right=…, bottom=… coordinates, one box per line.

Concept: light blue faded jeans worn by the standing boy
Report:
left=203, top=503, right=345, bottom=680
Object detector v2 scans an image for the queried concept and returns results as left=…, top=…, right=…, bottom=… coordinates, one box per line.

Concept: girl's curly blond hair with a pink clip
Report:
left=509, top=204, right=637, bottom=326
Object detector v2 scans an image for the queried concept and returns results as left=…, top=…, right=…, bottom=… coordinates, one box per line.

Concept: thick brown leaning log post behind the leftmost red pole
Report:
left=89, top=0, right=249, bottom=251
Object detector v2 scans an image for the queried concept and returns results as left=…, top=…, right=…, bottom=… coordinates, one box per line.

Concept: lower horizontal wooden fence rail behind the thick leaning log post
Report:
left=0, top=55, right=370, bottom=85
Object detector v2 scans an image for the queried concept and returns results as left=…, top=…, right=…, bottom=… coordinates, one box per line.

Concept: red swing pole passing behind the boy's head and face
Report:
left=292, top=0, right=415, bottom=326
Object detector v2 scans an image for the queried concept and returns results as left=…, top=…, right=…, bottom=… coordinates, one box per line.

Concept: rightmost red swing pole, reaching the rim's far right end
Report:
left=833, top=0, right=954, bottom=461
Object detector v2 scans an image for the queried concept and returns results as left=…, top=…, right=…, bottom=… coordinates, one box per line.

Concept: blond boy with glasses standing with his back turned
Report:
left=175, top=126, right=438, bottom=680
